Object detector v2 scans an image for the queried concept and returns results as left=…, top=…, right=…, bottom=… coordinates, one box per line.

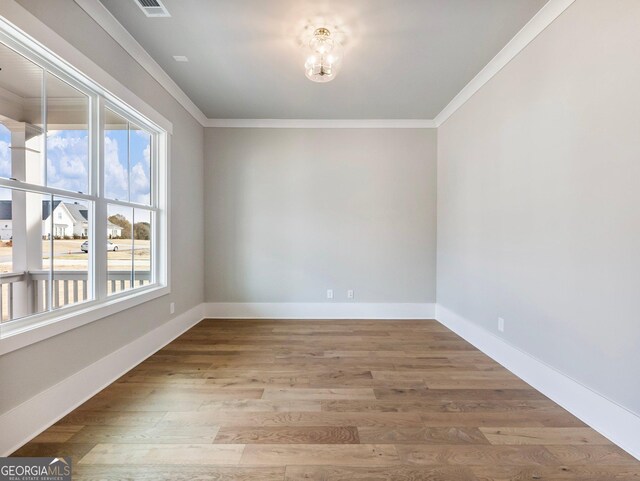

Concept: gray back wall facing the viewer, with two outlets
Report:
left=205, top=129, right=436, bottom=302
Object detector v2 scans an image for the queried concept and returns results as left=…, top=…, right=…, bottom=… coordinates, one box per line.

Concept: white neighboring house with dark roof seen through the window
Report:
left=0, top=200, right=122, bottom=240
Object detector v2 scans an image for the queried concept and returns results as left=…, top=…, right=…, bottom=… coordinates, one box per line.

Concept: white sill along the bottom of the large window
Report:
left=0, top=286, right=171, bottom=355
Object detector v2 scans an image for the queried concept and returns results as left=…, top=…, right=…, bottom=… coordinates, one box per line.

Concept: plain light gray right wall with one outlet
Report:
left=438, top=0, right=640, bottom=414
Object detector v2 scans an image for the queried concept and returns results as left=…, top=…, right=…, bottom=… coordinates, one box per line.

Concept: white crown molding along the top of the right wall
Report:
left=435, top=0, right=575, bottom=127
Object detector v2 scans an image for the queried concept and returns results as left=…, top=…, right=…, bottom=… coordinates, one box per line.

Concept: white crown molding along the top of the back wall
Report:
left=205, top=119, right=436, bottom=129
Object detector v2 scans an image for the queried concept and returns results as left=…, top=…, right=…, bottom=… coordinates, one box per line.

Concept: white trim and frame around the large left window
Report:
left=0, top=6, right=173, bottom=355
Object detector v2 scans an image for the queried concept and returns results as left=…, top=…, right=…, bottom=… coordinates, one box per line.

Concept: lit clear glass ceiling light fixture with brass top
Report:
left=304, top=27, right=342, bottom=82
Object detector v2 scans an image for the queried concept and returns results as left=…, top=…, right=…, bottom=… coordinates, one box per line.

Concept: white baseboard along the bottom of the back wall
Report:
left=204, top=302, right=436, bottom=319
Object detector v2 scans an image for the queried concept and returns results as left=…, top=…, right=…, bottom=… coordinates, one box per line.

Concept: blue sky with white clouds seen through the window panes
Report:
left=0, top=124, right=151, bottom=219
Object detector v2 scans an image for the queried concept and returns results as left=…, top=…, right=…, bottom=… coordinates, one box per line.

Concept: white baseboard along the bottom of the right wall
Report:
left=436, top=304, right=640, bottom=460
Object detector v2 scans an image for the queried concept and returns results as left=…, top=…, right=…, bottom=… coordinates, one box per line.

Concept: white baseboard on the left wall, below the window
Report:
left=0, top=304, right=203, bottom=456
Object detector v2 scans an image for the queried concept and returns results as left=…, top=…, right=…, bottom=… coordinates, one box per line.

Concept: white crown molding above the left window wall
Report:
left=74, top=0, right=207, bottom=126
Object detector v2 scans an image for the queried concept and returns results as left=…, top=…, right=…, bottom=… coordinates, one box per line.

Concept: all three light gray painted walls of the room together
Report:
left=5, top=0, right=640, bottom=428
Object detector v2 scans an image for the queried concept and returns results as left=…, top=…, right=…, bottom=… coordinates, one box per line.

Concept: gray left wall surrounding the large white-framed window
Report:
left=0, top=0, right=204, bottom=413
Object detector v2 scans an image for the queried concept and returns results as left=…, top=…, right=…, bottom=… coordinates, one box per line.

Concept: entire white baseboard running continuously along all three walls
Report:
left=0, top=303, right=640, bottom=459
